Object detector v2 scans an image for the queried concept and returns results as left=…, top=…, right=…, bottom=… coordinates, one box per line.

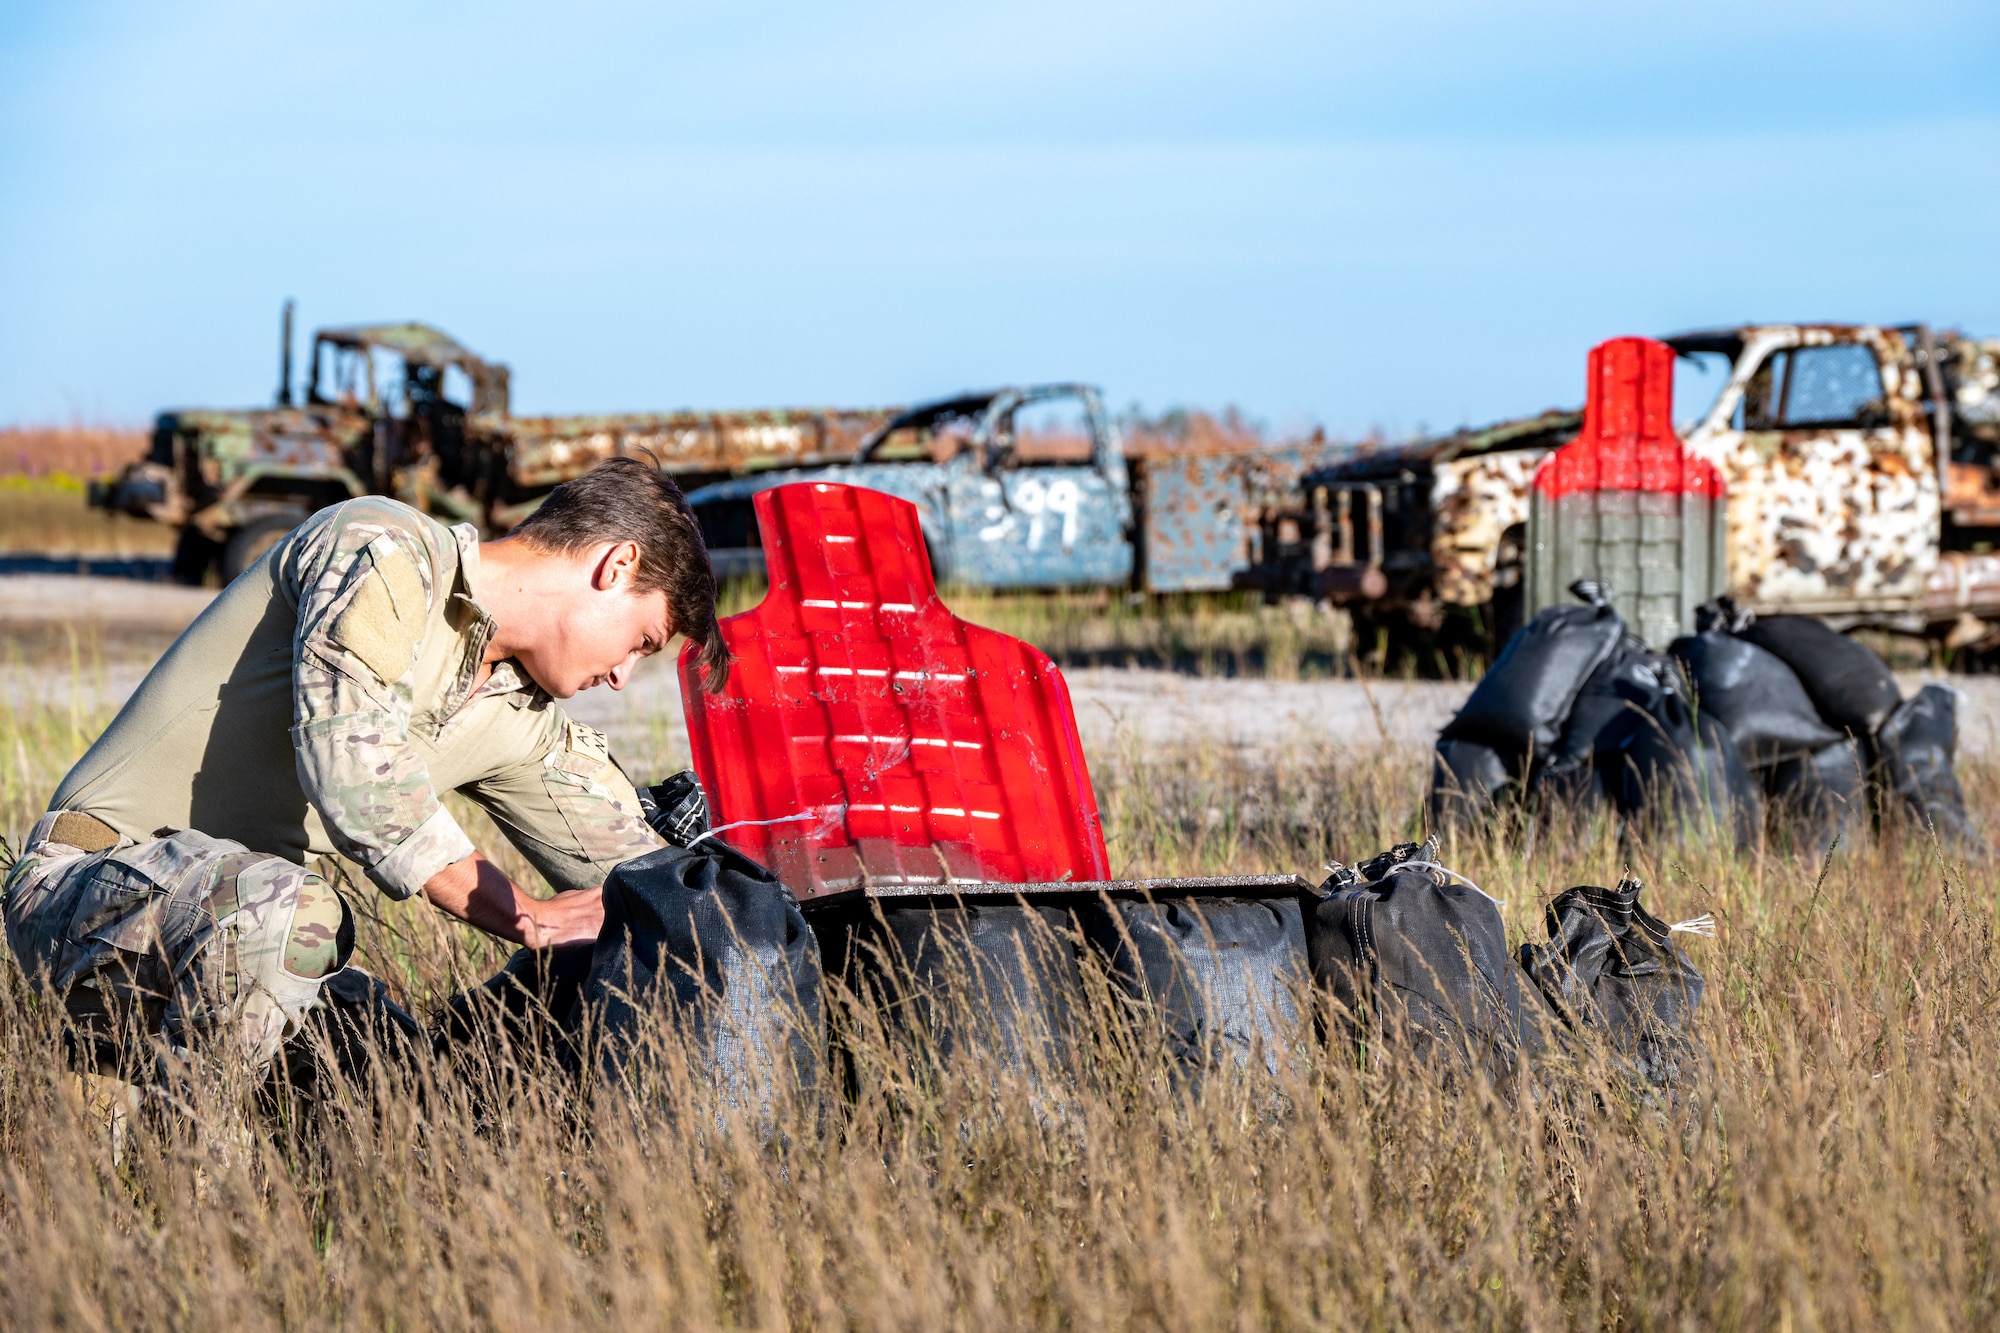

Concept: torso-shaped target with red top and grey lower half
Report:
left=1526, top=338, right=1722, bottom=648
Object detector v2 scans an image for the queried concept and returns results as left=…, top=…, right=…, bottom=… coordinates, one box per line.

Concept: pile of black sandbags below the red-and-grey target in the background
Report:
left=1430, top=580, right=1974, bottom=853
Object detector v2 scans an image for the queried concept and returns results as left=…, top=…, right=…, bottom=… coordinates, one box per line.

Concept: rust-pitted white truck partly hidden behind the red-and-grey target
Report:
left=1240, top=324, right=2000, bottom=646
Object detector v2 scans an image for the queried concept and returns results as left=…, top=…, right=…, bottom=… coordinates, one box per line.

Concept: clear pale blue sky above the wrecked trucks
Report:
left=0, top=0, right=2000, bottom=434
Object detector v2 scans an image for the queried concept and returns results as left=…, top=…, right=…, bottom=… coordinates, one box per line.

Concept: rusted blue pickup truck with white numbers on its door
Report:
left=688, top=382, right=1344, bottom=592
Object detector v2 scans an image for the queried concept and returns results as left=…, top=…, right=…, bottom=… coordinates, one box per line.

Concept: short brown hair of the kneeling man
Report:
left=508, top=458, right=730, bottom=695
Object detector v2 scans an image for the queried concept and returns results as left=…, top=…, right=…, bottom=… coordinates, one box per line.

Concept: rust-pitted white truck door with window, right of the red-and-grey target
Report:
left=1688, top=326, right=1938, bottom=614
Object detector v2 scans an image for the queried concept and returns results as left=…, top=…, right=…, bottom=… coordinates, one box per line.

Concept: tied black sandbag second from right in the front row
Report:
left=1306, top=843, right=1540, bottom=1069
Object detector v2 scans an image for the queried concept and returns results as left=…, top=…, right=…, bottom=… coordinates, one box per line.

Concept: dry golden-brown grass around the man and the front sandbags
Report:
left=0, top=644, right=2000, bottom=1329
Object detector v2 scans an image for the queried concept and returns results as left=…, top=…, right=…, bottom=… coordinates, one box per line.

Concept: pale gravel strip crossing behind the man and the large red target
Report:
left=11, top=574, right=2000, bottom=757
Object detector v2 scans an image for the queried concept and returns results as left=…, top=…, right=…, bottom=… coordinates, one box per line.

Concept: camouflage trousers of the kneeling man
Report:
left=4, top=813, right=354, bottom=1069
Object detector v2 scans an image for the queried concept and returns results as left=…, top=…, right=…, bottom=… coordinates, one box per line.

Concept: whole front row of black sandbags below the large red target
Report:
left=422, top=775, right=1700, bottom=1109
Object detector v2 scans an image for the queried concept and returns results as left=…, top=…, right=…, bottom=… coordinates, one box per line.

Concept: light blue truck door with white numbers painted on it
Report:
left=946, top=386, right=1132, bottom=588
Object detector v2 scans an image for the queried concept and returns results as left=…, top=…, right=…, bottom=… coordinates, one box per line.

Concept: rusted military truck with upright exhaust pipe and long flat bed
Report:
left=90, top=306, right=892, bottom=582
